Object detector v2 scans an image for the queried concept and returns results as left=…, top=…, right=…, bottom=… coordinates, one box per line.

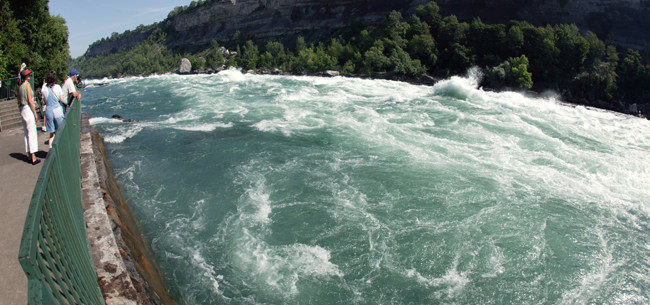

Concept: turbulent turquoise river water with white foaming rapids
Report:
left=83, top=70, right=650, bottom=304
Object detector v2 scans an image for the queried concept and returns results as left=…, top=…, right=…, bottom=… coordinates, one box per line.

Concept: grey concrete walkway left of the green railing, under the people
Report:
left=0, top=123, right=49, bottom=305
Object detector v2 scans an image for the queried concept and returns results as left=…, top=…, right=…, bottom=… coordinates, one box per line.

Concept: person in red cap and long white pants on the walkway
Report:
left=17, top=68, right=41, bottom=165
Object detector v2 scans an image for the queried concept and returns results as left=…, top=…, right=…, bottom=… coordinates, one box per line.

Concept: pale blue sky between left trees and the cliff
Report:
left=49, top=0, right=192, bottom=58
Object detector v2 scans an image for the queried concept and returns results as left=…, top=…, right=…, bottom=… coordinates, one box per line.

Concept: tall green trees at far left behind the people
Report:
left=0, top=0, right=70, bottom=82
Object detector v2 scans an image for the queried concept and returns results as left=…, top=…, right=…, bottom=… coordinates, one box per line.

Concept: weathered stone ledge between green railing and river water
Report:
left=81, top=115, right=176, bottom=305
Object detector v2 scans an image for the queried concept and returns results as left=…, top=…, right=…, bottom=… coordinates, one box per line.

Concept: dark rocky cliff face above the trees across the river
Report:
left=86, top=0, right=650, bottom=56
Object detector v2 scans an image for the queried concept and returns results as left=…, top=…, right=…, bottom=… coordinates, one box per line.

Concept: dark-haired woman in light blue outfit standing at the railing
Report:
left=43, top=71, right=65, bottom=148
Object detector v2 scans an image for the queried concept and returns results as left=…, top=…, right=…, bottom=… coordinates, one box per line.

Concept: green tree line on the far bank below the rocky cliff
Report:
left=74, top=1, right=650, bottom=115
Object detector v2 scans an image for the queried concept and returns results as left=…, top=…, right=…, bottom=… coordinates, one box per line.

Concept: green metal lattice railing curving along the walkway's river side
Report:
left=18, top=100, right=105, bottom=304
